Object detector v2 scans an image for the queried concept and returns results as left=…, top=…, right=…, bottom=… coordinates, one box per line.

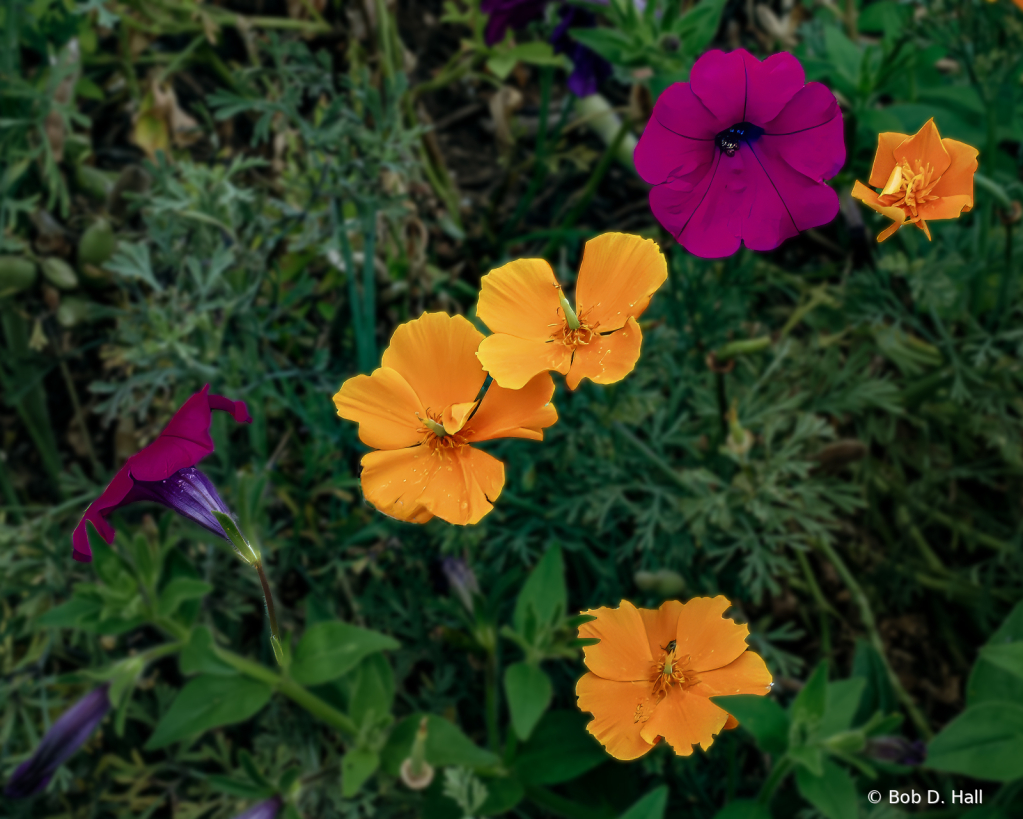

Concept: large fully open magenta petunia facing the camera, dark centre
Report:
left=634, top=49, right=845, bottom=259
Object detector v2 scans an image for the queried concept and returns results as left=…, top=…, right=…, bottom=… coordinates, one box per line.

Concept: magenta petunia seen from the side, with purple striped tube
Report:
left=72, top=384, right=252, bottom=563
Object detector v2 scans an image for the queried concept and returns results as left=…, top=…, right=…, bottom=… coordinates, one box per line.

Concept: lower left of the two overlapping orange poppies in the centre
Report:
left=333, top=313, right=558, bottom=524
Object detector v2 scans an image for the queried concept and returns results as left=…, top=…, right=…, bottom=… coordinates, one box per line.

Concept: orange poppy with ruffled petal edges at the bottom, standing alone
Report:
left=576, top=596, right=771, bottom=760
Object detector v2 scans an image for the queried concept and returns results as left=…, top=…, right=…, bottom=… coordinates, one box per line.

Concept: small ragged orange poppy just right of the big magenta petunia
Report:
left=852, top=118, right=977, bottom=241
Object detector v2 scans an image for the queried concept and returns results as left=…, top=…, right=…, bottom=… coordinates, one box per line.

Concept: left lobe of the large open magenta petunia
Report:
left=633, top=83, right=727, bottom=185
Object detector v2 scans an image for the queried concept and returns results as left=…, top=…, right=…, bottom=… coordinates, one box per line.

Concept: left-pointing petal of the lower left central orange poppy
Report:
left=333, top=367, right=424, bottom=449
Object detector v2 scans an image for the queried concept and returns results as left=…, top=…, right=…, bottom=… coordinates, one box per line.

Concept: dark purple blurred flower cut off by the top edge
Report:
left=480, top=0, right=605, bottom=97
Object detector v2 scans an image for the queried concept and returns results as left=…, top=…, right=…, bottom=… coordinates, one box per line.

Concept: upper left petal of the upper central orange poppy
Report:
left=476, top=259, right=565, bottom=339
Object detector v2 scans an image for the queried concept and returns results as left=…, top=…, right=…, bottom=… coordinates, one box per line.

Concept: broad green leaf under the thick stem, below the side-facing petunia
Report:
left=145, top=675, right=272, bottom=750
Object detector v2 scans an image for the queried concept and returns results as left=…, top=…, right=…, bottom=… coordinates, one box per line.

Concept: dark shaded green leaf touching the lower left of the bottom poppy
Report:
left=513, top=711, right=609, bottom=786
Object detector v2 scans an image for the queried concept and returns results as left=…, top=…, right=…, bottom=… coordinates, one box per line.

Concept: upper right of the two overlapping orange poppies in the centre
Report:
left=476, top=233, right=668, bottom=390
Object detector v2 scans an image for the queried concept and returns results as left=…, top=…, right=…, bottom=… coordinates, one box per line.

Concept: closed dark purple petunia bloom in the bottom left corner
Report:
left=3, top=685, right=110, bottom=800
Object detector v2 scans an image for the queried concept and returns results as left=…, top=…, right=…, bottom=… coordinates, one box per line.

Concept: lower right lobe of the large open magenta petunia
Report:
left=739, top=141, right=839, bottom=251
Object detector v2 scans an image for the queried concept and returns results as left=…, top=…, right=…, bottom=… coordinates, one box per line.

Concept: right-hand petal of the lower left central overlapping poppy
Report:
left=462, top=372, right=558, bottom=441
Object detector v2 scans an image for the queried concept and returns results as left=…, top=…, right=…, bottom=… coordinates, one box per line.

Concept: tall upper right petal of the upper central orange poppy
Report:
left=576, top=233, right=668, bottom=331
